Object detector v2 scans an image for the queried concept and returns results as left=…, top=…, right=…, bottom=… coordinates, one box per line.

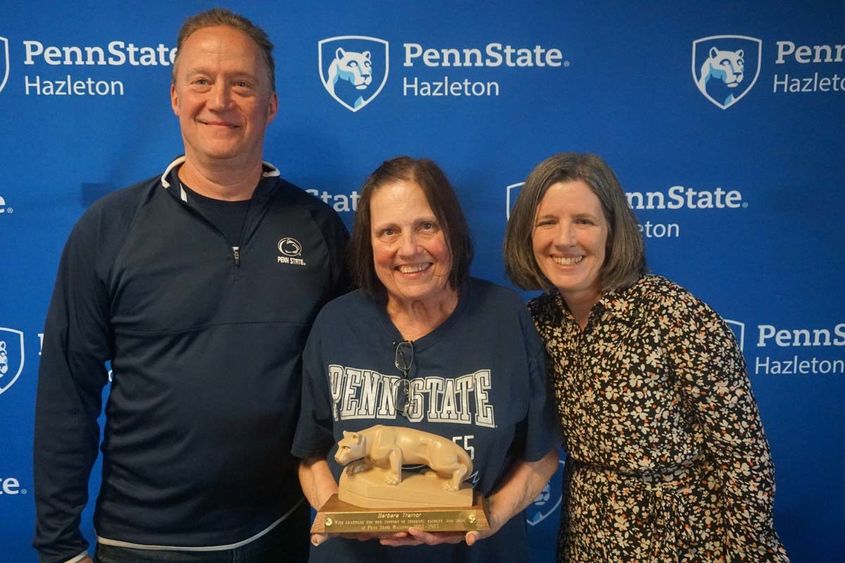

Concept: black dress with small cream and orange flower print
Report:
left=529, top=276, right=788, bottom=563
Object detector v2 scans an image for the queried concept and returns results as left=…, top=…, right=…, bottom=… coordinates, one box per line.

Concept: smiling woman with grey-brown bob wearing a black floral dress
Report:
left=505, top=153, right=788, bottom=563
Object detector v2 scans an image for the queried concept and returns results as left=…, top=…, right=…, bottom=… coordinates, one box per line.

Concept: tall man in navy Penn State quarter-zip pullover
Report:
left=34, top=9, right=347, bottom=562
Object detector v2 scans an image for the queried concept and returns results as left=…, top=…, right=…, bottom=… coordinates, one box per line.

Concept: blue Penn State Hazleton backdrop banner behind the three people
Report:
left=0, top=0, right=845, bottom=562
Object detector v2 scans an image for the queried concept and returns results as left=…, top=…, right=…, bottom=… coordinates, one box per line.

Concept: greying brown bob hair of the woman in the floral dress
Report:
left=504, top=153, right=646, bottom=291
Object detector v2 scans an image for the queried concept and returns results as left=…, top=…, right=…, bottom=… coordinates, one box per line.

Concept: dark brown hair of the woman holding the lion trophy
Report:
left=348, top=156, right=473, bottom=297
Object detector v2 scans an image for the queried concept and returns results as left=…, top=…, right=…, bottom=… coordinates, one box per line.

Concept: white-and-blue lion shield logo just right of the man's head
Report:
left=317, top=35, right=390, bottom=111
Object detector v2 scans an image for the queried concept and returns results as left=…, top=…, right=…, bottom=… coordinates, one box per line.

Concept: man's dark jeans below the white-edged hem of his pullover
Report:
left=94, top=502, right=310, bottom=563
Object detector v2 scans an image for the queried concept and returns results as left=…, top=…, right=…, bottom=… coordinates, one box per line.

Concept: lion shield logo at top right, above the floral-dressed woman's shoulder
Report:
left=692, top=35, right=763, bottom=109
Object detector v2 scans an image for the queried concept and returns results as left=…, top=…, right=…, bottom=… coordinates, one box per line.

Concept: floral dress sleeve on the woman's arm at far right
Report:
left=665, top=292, right=788, bottom=561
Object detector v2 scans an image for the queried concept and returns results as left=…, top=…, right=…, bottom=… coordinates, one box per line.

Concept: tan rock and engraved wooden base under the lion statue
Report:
left=311, top=467, right=490, bottom=534
